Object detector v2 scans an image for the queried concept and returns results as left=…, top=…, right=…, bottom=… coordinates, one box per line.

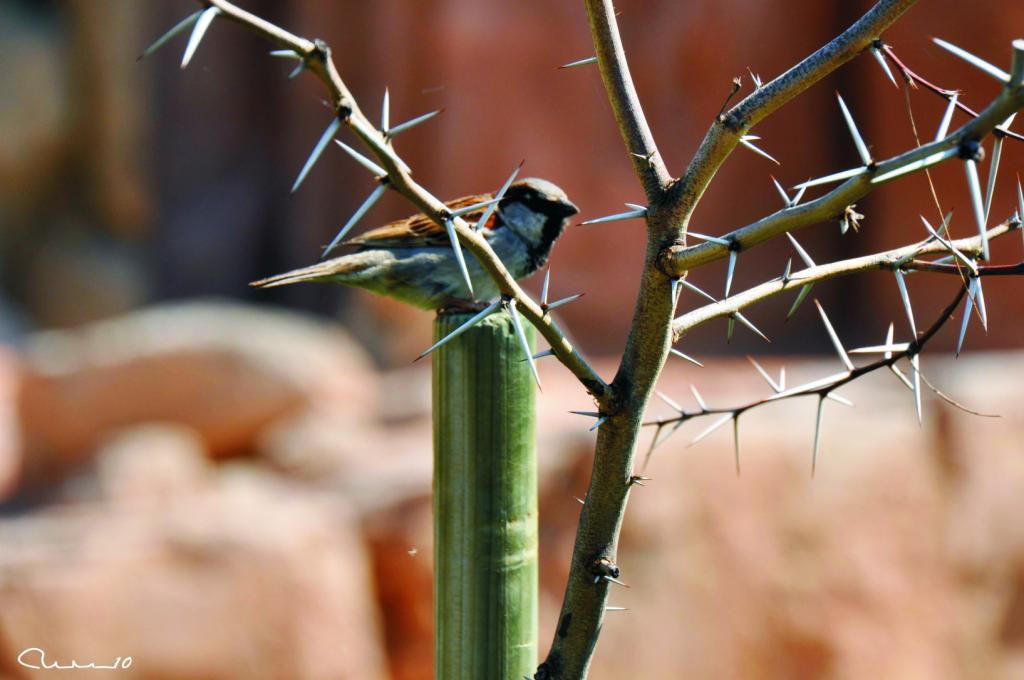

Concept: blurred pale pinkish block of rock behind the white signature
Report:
left=0, top=461, right=387, bottom=680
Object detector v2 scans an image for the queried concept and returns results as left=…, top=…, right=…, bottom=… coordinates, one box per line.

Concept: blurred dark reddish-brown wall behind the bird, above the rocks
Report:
left=0, top=0, right=1024, bottom=364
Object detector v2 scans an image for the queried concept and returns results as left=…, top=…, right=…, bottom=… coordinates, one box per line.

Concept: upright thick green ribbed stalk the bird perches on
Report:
left=433, top=311, right=538, bottom=680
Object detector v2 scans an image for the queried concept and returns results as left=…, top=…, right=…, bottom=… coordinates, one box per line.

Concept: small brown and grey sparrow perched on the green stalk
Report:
left=250, top=178, right=579, bottom=309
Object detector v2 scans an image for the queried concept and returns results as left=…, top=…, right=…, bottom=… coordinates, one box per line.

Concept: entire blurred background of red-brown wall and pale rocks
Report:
left=0, top=0, right=1024, bottom=680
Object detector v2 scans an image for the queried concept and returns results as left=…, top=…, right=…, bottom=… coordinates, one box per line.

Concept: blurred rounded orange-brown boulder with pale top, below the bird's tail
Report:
left=9, top=302, right=376, bottom=499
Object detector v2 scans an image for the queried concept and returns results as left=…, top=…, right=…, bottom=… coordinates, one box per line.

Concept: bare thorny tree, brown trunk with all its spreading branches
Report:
left=149, top=0, right=1024, bottom=679
